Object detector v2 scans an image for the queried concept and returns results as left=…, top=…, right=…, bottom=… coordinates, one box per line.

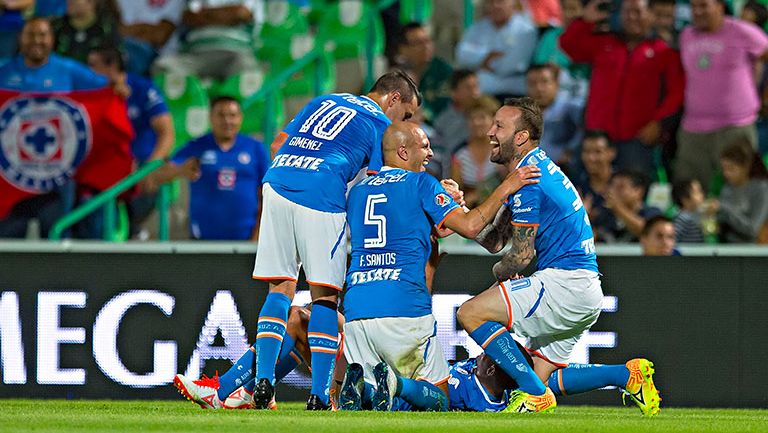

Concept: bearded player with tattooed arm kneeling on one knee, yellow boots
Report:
left=457, top=98, right=659, bottom=415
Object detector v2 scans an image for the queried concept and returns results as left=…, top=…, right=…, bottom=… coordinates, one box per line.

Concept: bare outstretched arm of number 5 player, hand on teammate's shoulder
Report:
left=443, top=165, right=541, bottom=239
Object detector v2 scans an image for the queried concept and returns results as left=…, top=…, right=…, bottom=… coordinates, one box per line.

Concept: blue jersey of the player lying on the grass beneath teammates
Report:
left=392, top=358, right=509, bottom=412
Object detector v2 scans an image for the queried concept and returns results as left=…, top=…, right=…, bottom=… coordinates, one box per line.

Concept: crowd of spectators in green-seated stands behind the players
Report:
left=0, top=0, right=768, bottom=246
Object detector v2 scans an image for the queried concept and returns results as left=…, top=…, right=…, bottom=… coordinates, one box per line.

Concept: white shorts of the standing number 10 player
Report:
left=253, top=183, right=347, bottom=290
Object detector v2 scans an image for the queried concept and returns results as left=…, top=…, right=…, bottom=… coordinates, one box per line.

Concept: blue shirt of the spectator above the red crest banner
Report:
left=0, top=54, right=107, bottom=92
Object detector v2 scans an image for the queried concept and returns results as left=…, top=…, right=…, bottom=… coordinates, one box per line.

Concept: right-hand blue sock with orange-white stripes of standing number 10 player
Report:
left=307, top=301, right=339, bottom=404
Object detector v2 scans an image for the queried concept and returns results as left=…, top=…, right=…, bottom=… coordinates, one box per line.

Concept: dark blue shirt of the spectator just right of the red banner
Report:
left=126, top=72, right=168, bottom=163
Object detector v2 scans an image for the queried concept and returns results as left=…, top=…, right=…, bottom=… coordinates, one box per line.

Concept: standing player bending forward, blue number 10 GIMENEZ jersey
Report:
left=253, top=71, right=421, bottom=410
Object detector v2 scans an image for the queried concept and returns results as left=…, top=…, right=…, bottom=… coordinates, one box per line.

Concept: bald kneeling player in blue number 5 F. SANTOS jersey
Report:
left=338, top=122, right=538, bottom=410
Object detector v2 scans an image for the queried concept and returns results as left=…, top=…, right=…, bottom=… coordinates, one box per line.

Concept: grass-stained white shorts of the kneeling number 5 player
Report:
left=344, top=314, right=450, bottom=385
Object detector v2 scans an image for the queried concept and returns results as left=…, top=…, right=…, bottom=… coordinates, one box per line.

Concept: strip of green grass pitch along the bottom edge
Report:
left=0, top=400, right=768, bottom=433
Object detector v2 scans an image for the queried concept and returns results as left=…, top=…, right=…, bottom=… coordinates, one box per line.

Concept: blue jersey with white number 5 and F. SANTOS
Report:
left=344, top=167, right=459, bottom=320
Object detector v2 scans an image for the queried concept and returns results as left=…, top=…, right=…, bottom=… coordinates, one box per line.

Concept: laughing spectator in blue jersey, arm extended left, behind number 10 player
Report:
left=154, top=96, right=269, bottom=240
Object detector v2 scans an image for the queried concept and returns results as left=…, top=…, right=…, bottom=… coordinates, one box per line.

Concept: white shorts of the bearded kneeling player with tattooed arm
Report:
left=499, top=269, right=603, bottom=366
